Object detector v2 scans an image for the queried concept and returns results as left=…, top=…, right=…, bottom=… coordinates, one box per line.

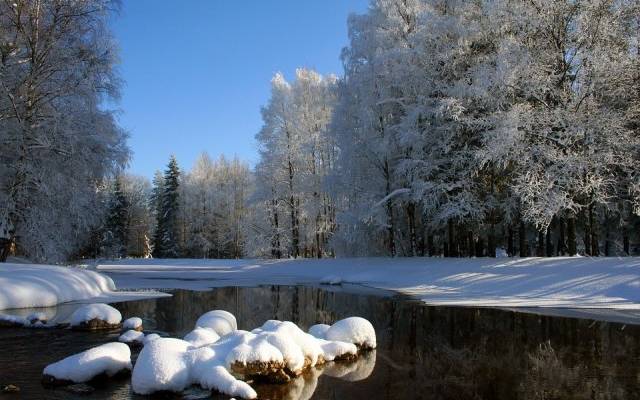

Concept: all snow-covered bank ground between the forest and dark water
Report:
left=0, top=257, right=640, bottom=310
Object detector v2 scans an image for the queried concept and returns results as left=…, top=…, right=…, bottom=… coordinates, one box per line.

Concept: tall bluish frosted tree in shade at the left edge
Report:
left=0, top=0, right=129, bottom=261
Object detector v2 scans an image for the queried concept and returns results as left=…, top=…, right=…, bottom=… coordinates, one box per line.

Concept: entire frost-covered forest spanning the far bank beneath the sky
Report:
left=0, top=0, right=640, bottom=262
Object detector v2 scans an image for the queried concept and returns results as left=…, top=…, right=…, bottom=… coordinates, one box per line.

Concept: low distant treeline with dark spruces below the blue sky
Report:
left=83, top=153, right=252, bottom=258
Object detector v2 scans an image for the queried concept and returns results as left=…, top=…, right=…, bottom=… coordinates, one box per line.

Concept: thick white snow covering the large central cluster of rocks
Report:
left=131, top=310, right=376, bottom=399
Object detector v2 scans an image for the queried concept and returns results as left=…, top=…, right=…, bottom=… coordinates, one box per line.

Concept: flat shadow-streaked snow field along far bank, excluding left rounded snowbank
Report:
left=94, top=257, right=640, bottom=310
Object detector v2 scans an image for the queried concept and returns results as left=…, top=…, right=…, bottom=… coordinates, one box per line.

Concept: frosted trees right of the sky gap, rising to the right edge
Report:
left=256, top=0, right=640, bottom=257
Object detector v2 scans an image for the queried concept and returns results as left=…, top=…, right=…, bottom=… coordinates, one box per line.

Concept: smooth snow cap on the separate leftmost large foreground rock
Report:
left=43, top=343, right=131, bottom=383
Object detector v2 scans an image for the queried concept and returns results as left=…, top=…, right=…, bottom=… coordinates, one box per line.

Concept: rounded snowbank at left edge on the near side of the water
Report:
left=0, top=263, right=166, bottom=310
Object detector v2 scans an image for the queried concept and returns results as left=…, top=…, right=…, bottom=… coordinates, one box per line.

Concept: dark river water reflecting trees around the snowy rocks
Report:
left=0, top=286, right=640, bottom=400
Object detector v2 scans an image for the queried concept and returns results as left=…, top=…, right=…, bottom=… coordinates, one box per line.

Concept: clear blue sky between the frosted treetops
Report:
left=112, top=0, right=368, bottom=177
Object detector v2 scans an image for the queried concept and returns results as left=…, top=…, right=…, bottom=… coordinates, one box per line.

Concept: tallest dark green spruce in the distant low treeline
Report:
left=153, top=156, right=180, bottom=258
